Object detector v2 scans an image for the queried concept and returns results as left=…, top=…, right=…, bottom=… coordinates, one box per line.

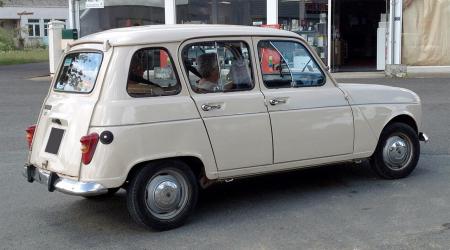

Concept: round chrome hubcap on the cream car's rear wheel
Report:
left=145, top=170, right=187, bottom=219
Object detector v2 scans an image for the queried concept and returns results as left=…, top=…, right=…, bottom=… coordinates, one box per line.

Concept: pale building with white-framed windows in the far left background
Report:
left=0, top=0, right=69, bottom=46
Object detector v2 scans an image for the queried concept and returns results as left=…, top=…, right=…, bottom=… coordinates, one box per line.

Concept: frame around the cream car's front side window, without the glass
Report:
left=255, top=37, right=328, bottom=90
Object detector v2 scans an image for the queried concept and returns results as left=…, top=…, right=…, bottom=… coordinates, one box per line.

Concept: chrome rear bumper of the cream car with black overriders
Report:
left=23, top=165, right=108, bottom=196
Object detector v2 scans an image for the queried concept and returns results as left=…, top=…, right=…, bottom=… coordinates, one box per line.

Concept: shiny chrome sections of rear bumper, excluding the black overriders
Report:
left=22, top=167, right=108, bottom=196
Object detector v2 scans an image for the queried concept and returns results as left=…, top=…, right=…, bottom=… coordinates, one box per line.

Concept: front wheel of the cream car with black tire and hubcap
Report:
left=370, top=123, right=420, bottom=179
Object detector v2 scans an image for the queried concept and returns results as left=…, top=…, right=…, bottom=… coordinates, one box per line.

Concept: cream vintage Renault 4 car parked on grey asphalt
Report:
left=24, top=25, right=427, bottom=230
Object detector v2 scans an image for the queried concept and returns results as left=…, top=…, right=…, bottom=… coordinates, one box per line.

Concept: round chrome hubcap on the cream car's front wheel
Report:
left=383, top=135, right=412, bottom=170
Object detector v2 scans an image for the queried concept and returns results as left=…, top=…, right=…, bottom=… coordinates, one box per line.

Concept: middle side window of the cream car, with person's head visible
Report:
left=183, top=41, right=254, bottom=93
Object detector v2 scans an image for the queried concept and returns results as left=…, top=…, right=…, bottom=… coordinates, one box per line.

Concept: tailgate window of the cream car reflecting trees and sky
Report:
left=55, top=52, right=103, bottom=93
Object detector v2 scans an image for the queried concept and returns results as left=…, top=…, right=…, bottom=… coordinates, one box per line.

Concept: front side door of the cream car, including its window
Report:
left=254, top=38, right=353, bottom=163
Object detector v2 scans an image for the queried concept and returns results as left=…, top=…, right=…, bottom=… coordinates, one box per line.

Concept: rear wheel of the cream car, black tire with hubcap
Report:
left=127, top=160, right=198, bottom=231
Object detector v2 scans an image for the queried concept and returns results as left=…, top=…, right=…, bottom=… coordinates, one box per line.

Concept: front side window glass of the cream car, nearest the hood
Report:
left=258, top=41, right=326, bottom=88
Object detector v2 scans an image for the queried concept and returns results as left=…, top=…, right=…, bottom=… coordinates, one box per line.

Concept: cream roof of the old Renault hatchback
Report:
left=72, top=24, right=300, bottom=46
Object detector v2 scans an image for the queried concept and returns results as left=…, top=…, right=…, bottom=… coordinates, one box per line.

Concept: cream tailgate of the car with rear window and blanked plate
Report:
left=30, top=45, right=112, bottom=177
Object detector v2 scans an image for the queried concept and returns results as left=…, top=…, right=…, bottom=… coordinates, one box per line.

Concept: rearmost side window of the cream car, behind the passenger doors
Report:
left=127, top=48, right=181, bottom=97
